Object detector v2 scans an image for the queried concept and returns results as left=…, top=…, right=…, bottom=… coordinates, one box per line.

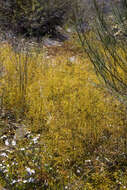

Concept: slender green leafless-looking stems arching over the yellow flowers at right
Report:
left=75, top=0, right=127, bottom=105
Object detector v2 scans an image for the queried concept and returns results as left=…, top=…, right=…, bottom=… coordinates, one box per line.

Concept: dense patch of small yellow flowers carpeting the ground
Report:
left=0, top=39, right=126, bottom=190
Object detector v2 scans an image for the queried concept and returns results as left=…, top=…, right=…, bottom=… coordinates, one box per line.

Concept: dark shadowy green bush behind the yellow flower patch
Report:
left=0, top=0, right=74, bottom=38
